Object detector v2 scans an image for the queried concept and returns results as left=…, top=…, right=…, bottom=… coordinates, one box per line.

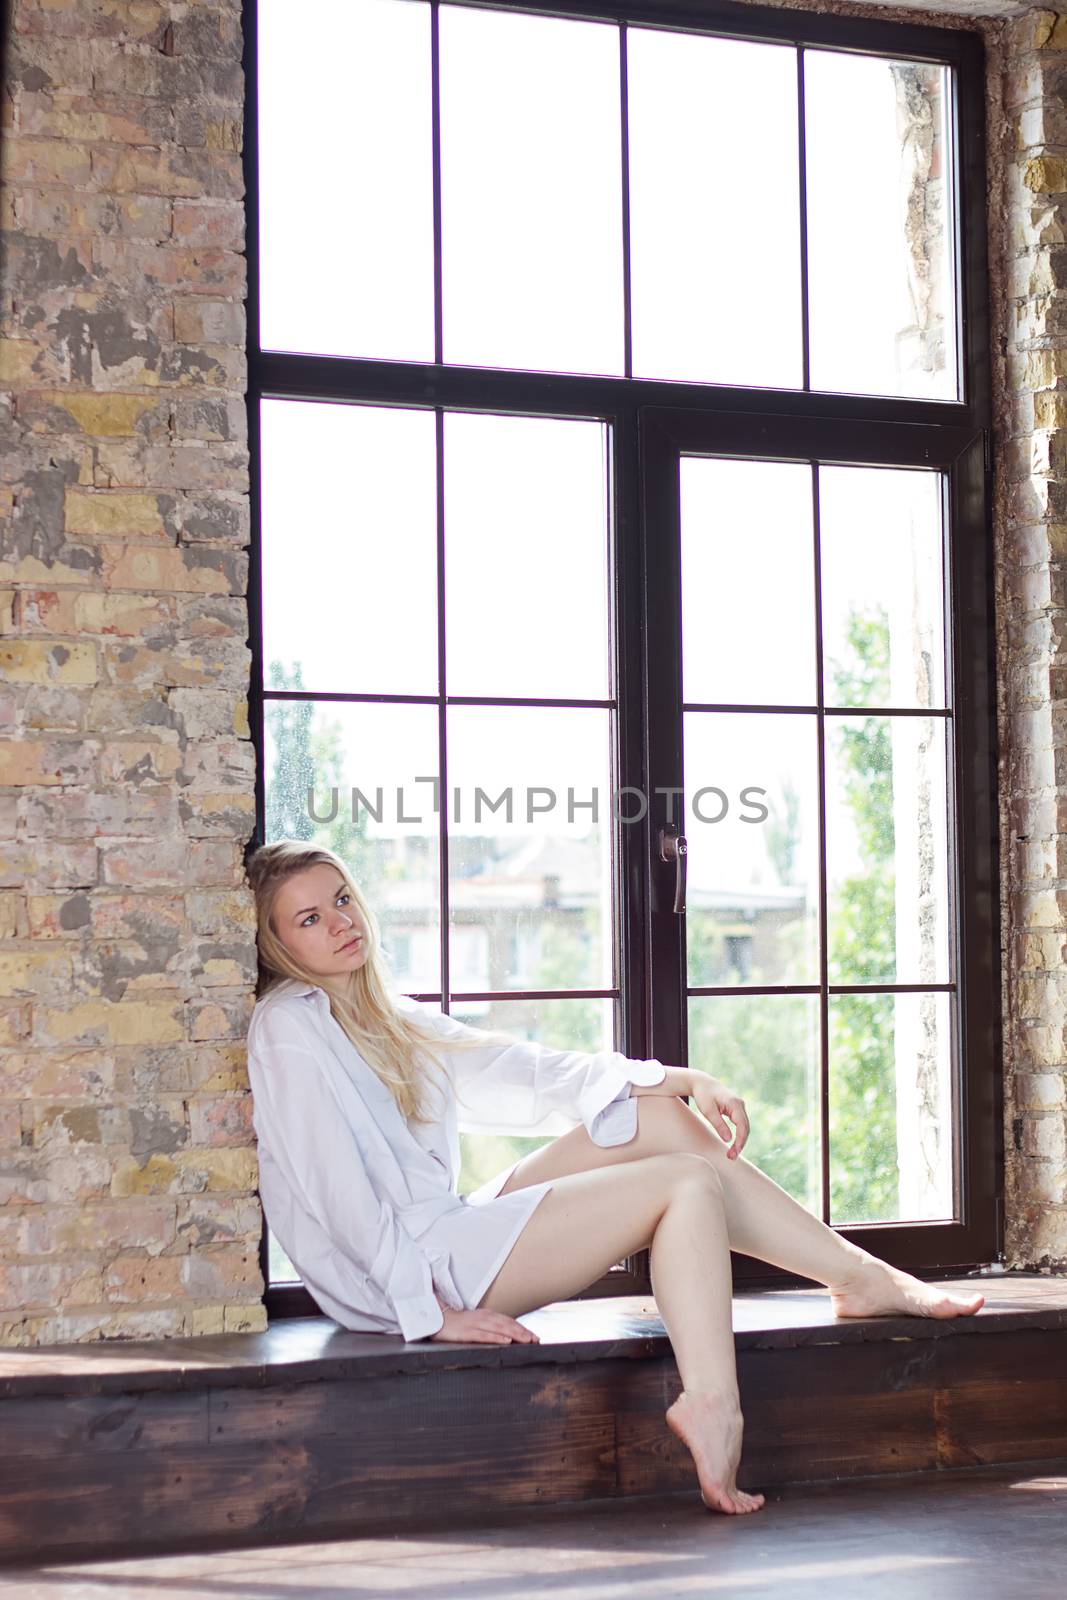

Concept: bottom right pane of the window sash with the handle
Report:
left=830, top=992, right=955, bottom=1224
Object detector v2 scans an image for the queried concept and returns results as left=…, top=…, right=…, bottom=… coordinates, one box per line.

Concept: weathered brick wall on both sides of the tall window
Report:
left=0, top=0, right=1067, bottom=1344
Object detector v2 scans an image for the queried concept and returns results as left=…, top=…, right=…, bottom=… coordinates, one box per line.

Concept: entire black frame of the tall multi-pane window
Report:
left=243, top=0, right=1003, bottom=1317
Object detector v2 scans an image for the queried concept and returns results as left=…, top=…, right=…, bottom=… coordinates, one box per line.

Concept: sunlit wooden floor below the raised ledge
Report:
left=0, top=1459, right=1067, bottom=1600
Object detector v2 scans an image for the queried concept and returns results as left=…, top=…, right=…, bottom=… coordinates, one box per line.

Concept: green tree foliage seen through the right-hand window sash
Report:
left=686, top=608, right=897, bottom=1224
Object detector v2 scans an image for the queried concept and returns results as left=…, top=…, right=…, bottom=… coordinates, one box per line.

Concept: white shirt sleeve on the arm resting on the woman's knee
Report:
left=403, top=1005, right=667, bottom=1144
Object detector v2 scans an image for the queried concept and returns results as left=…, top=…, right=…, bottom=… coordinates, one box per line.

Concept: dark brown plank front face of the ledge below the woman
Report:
left=0, top=1305, right=1067, bottom=1557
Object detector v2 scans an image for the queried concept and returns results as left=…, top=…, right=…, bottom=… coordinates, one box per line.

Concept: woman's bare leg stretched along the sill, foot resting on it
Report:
left=501, top=1094, right=985, bottom=1317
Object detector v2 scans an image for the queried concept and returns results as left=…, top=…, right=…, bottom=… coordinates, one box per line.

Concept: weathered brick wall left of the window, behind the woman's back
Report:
left=0, top=0, right=266, bottom=1344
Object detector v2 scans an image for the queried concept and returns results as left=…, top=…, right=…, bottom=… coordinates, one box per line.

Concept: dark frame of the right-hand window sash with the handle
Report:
left=641, top=408, right=1001, bottom=1283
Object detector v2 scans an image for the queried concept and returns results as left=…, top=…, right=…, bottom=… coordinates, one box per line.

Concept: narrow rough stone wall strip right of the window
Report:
left=990, top=11, right=1067, bottom=1270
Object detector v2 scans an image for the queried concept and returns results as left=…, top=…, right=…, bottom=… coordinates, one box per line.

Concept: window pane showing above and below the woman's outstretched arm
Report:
left=451, top=1000, right=619, bottom=1195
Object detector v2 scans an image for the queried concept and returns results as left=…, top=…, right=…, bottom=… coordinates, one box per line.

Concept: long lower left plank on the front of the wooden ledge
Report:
left=0, top=1416, right=614, bottom=1558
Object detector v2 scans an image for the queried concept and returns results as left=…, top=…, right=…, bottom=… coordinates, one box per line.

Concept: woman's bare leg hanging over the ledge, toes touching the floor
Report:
left=480, top=1152, right=763, bottom=1512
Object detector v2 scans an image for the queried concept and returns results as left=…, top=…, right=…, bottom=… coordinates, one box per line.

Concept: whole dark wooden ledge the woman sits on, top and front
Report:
left=0, top=1274, right=1067, bottom=1563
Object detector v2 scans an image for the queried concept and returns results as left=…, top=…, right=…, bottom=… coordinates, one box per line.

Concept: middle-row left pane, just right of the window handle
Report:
left=687, top=712, right=819, bottom=987
